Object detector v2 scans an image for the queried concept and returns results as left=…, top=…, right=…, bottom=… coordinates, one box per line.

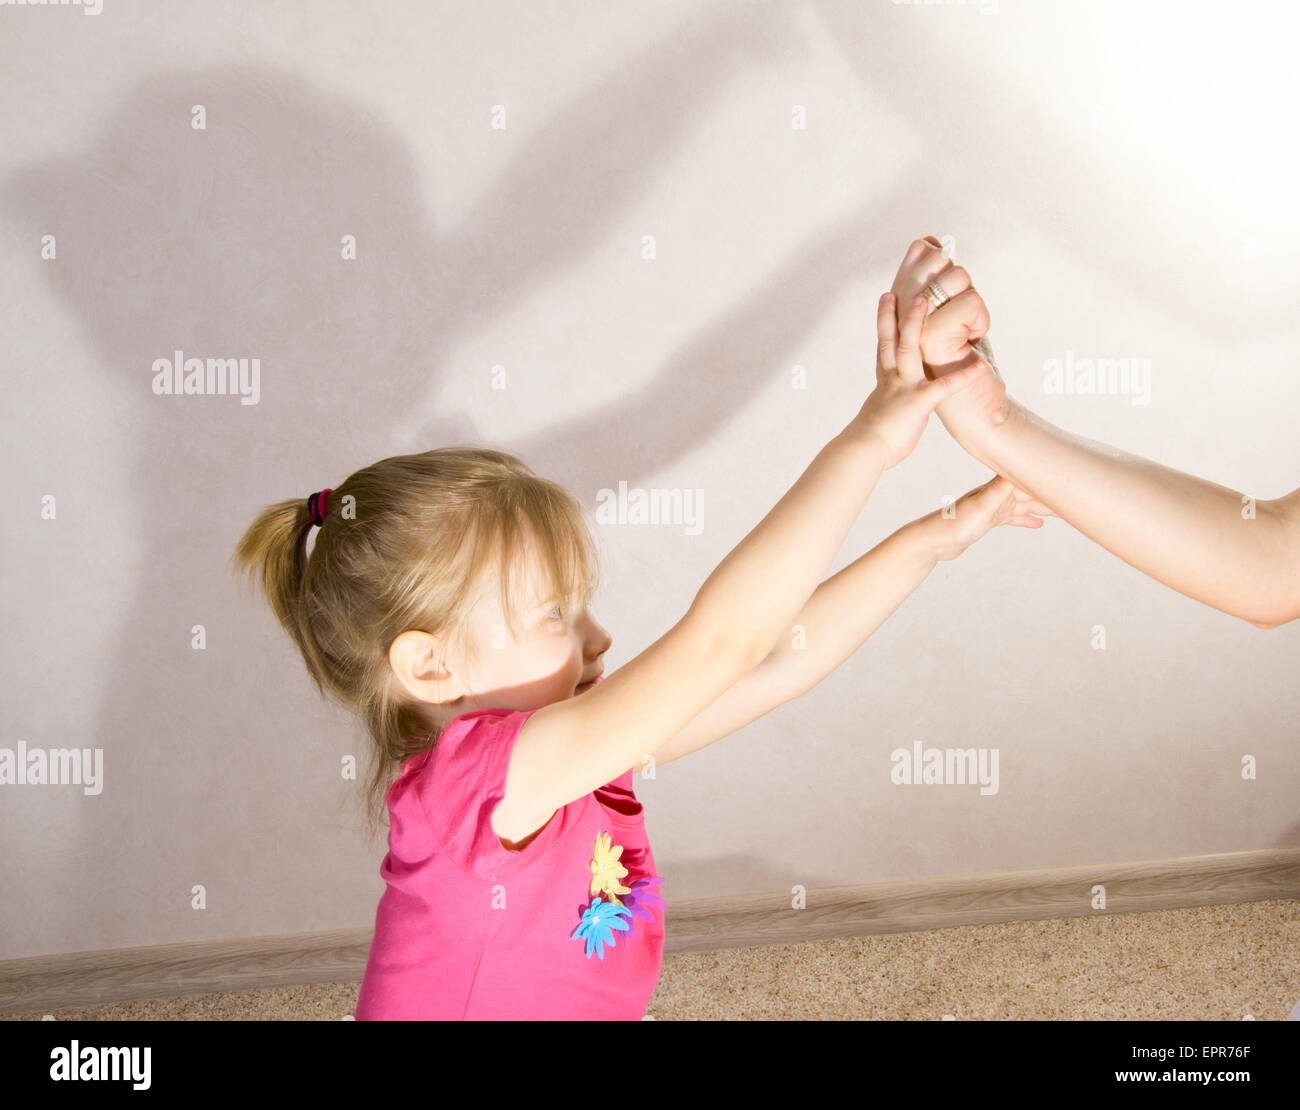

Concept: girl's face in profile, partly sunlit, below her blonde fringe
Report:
left=459, top=548, right=612, bottom=712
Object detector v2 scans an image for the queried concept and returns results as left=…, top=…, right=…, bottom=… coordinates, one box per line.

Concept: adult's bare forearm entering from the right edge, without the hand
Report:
left=971, top=402, right=1300, bottom=626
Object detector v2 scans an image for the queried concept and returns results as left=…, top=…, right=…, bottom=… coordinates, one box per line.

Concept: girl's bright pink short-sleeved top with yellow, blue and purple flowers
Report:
left=356, top=710, right=667, bottom=1022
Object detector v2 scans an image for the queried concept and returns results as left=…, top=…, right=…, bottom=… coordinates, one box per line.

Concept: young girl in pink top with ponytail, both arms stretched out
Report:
left=235, top=294, right=1041, bottom=1020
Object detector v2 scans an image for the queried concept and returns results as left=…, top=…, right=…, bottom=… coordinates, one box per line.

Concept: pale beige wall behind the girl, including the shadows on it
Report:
left=0, top=0, right=1300, bottom=958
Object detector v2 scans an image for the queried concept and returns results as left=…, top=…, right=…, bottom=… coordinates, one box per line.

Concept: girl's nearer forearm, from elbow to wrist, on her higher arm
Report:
left=692, top=419, right=885, bottom=662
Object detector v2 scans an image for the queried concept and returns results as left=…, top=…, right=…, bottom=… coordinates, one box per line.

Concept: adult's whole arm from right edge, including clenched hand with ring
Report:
left=893, top=238, right=1300, bottom=628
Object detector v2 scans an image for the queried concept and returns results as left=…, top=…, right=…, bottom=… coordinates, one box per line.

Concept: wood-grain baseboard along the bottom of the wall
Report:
left=0, top=847, right=1300, bottom=1014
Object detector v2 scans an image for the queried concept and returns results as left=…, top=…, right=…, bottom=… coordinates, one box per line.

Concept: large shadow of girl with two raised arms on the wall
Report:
left=0, top=4, right=946, bottom=950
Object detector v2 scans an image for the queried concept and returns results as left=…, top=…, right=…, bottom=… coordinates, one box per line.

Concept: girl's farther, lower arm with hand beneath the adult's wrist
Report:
left=654, top=478, right=1043, bottom=764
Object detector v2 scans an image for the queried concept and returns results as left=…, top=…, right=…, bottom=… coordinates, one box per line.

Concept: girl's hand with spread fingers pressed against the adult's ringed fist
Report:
left=858, top=292, right=992, bottom=468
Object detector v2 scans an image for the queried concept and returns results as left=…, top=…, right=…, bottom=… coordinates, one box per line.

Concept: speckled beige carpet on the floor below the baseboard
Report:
left=8, top=899, right=1300, bottom=1022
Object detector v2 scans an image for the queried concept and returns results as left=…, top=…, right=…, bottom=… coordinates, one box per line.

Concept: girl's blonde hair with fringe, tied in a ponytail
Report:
left=231, top=447, right=598, bottom=833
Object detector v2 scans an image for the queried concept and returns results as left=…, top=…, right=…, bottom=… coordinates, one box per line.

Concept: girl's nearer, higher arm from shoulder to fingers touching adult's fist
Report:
left=493, top=294, right=988, bottom=841
